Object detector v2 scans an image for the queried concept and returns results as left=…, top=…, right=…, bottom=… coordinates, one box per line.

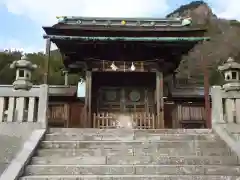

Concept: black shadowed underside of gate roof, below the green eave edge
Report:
left=55, top=43, right=193, bottom=61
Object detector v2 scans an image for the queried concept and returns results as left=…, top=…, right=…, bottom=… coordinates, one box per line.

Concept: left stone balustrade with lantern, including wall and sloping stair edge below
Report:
left=0, top=56, right=48, bottom=180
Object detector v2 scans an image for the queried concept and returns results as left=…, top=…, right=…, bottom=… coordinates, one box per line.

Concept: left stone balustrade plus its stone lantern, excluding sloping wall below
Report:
left=0, top=56, right=48, bottom=127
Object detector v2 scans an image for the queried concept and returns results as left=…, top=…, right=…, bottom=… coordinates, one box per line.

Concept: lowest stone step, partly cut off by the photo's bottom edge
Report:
left=20, top=175, right=239, bottom=180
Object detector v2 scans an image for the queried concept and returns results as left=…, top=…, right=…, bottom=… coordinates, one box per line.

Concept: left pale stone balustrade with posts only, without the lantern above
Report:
left=0, top=84, right=48, bottom=127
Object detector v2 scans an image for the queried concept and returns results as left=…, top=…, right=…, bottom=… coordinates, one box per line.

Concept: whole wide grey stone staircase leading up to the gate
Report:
left=20, top=128, right=240, bottom=180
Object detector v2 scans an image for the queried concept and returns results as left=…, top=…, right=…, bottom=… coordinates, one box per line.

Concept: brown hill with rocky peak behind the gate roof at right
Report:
left=167, top=1, right=240, bottom=84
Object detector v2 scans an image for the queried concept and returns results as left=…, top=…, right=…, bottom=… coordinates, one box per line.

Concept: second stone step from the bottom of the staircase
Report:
left=25, top=165, right=240, bottom=176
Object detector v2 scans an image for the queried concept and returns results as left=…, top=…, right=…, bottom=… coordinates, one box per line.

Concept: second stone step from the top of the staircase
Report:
left=45, top=133, right=220, bottom=141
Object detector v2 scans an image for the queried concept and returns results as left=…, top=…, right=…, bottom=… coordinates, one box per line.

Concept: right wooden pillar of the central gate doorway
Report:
left=156, top=71, right=164, bottom=128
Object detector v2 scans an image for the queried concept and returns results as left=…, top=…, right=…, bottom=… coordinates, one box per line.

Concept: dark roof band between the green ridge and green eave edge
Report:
left=43, top=24, right=206, bottom=37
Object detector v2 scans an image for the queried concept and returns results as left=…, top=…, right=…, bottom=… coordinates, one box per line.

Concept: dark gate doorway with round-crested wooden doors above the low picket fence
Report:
left=92, top=72, right=156, bottom=113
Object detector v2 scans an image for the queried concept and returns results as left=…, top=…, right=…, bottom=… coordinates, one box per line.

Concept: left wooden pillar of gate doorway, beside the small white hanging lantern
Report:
left=85, top=71, right=92, bottom=128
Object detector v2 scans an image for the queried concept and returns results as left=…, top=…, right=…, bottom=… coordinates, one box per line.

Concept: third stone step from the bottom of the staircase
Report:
left=31, top=155, right=239, bottom=165
